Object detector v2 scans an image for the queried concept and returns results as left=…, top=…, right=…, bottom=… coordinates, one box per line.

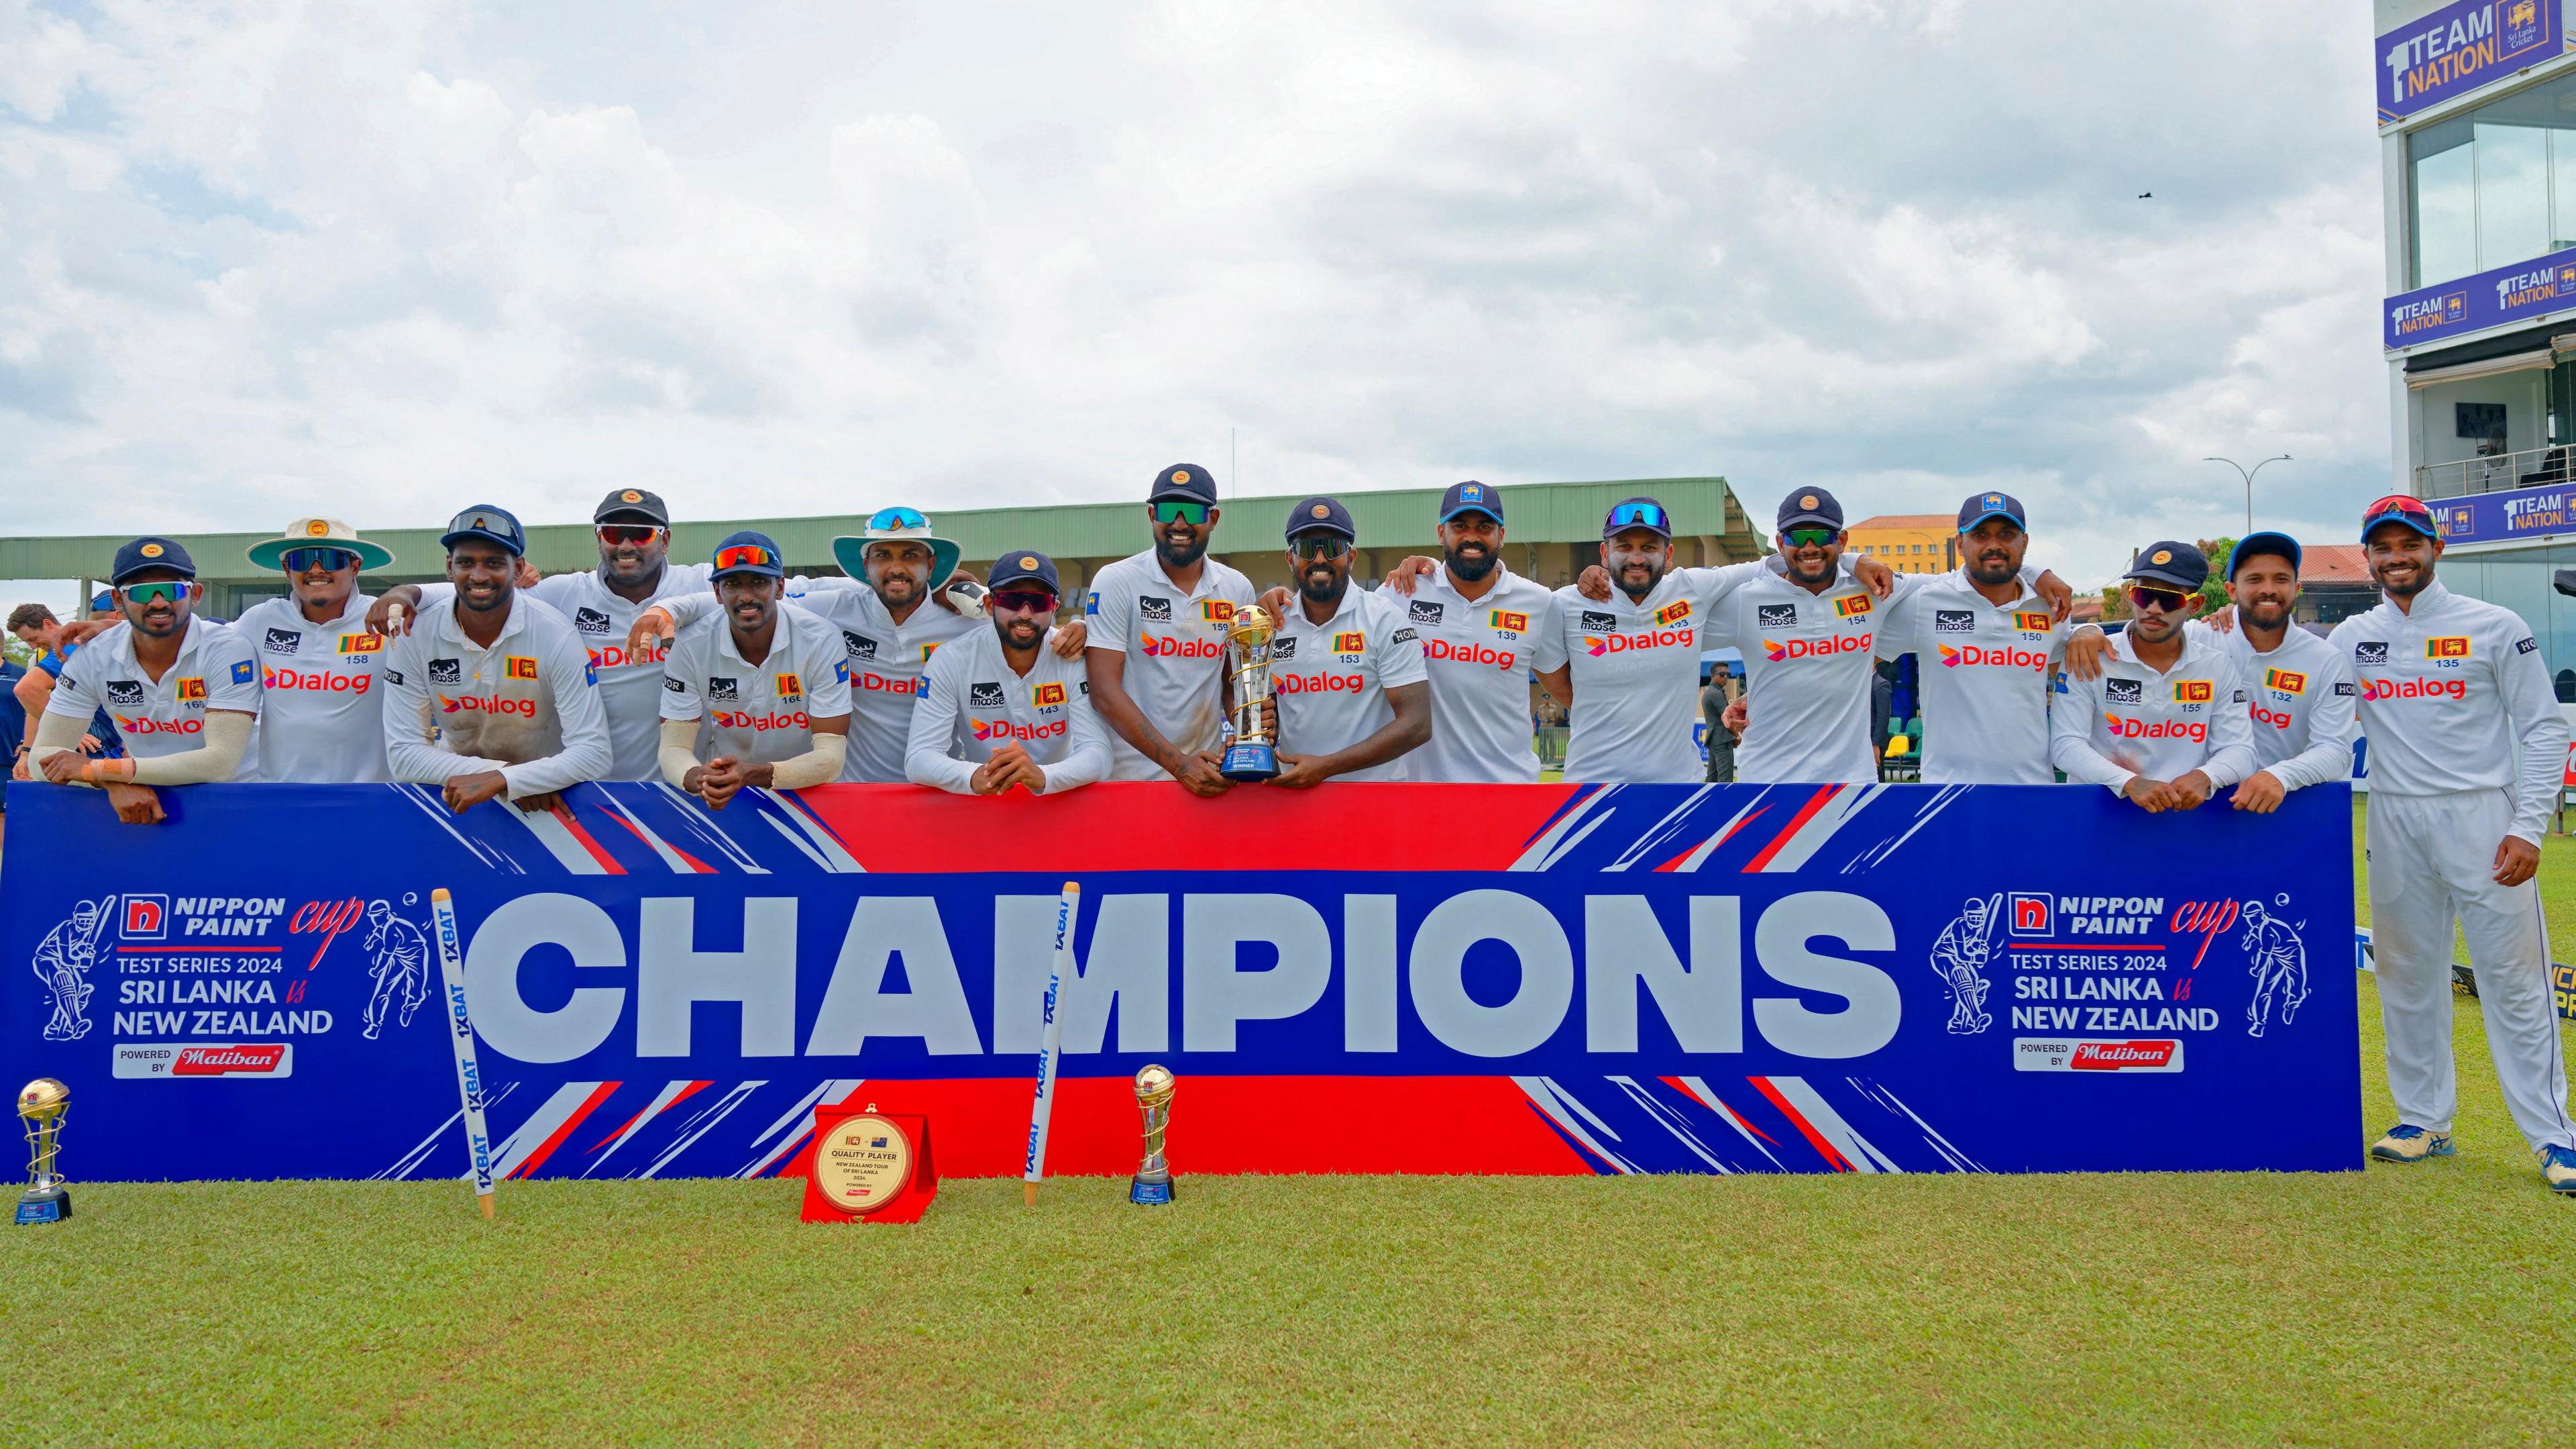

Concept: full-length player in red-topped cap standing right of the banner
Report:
left=2326, top=495, right=2576, bottom=1194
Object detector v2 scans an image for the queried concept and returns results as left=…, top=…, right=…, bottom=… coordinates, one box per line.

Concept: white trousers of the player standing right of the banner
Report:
left=2367, top=789, right=2576, bottom=1150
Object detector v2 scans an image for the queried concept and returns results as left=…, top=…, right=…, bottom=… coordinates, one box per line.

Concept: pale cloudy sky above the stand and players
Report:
left=0, top=0, right=2388, bottom=598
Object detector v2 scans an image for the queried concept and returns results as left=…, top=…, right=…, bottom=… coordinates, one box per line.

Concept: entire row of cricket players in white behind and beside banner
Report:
left=10, top=464, right=2576, bottom=1194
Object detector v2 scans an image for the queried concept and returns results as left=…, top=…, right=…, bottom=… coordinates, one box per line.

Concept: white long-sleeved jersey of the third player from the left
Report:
left=381, top=590, right=616, bottom=799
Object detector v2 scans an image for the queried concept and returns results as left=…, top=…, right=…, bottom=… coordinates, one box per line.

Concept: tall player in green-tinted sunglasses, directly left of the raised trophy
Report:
left=1085, top=464, right=1252, bottom=794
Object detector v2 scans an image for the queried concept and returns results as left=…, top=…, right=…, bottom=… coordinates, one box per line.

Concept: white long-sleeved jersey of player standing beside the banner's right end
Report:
left=2328, top=580, right=2568, bottom=843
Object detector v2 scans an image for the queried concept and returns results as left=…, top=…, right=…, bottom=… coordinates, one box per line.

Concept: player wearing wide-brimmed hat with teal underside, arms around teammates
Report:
left=636, top=505, right=1082, bottom=784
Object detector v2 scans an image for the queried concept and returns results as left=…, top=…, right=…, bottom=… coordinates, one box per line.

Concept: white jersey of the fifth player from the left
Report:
left=662, top=603, right=850, bottom=765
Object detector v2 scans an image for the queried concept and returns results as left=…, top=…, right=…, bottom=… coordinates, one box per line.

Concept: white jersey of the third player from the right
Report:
left=2048, top=632, right=2254, bottom=794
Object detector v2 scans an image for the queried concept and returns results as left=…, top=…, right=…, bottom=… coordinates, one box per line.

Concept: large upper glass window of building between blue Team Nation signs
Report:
left=2406, top=77, right=2576, bottom=286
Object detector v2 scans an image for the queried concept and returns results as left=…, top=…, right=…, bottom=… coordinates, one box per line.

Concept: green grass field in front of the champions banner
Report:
left=0, top=794, right=2576, bottom=1446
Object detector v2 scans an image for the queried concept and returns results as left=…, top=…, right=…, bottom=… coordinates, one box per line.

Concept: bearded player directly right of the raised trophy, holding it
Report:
left=1270, top=498, right=1432, bottom=789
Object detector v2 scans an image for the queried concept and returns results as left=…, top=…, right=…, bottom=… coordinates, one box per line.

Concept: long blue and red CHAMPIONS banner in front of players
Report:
left=0, top=784, right=2362, bottom=1181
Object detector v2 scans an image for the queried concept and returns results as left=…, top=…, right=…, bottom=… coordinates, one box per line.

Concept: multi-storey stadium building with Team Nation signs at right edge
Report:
left=2373, top=0, right=2576, bottom=704
